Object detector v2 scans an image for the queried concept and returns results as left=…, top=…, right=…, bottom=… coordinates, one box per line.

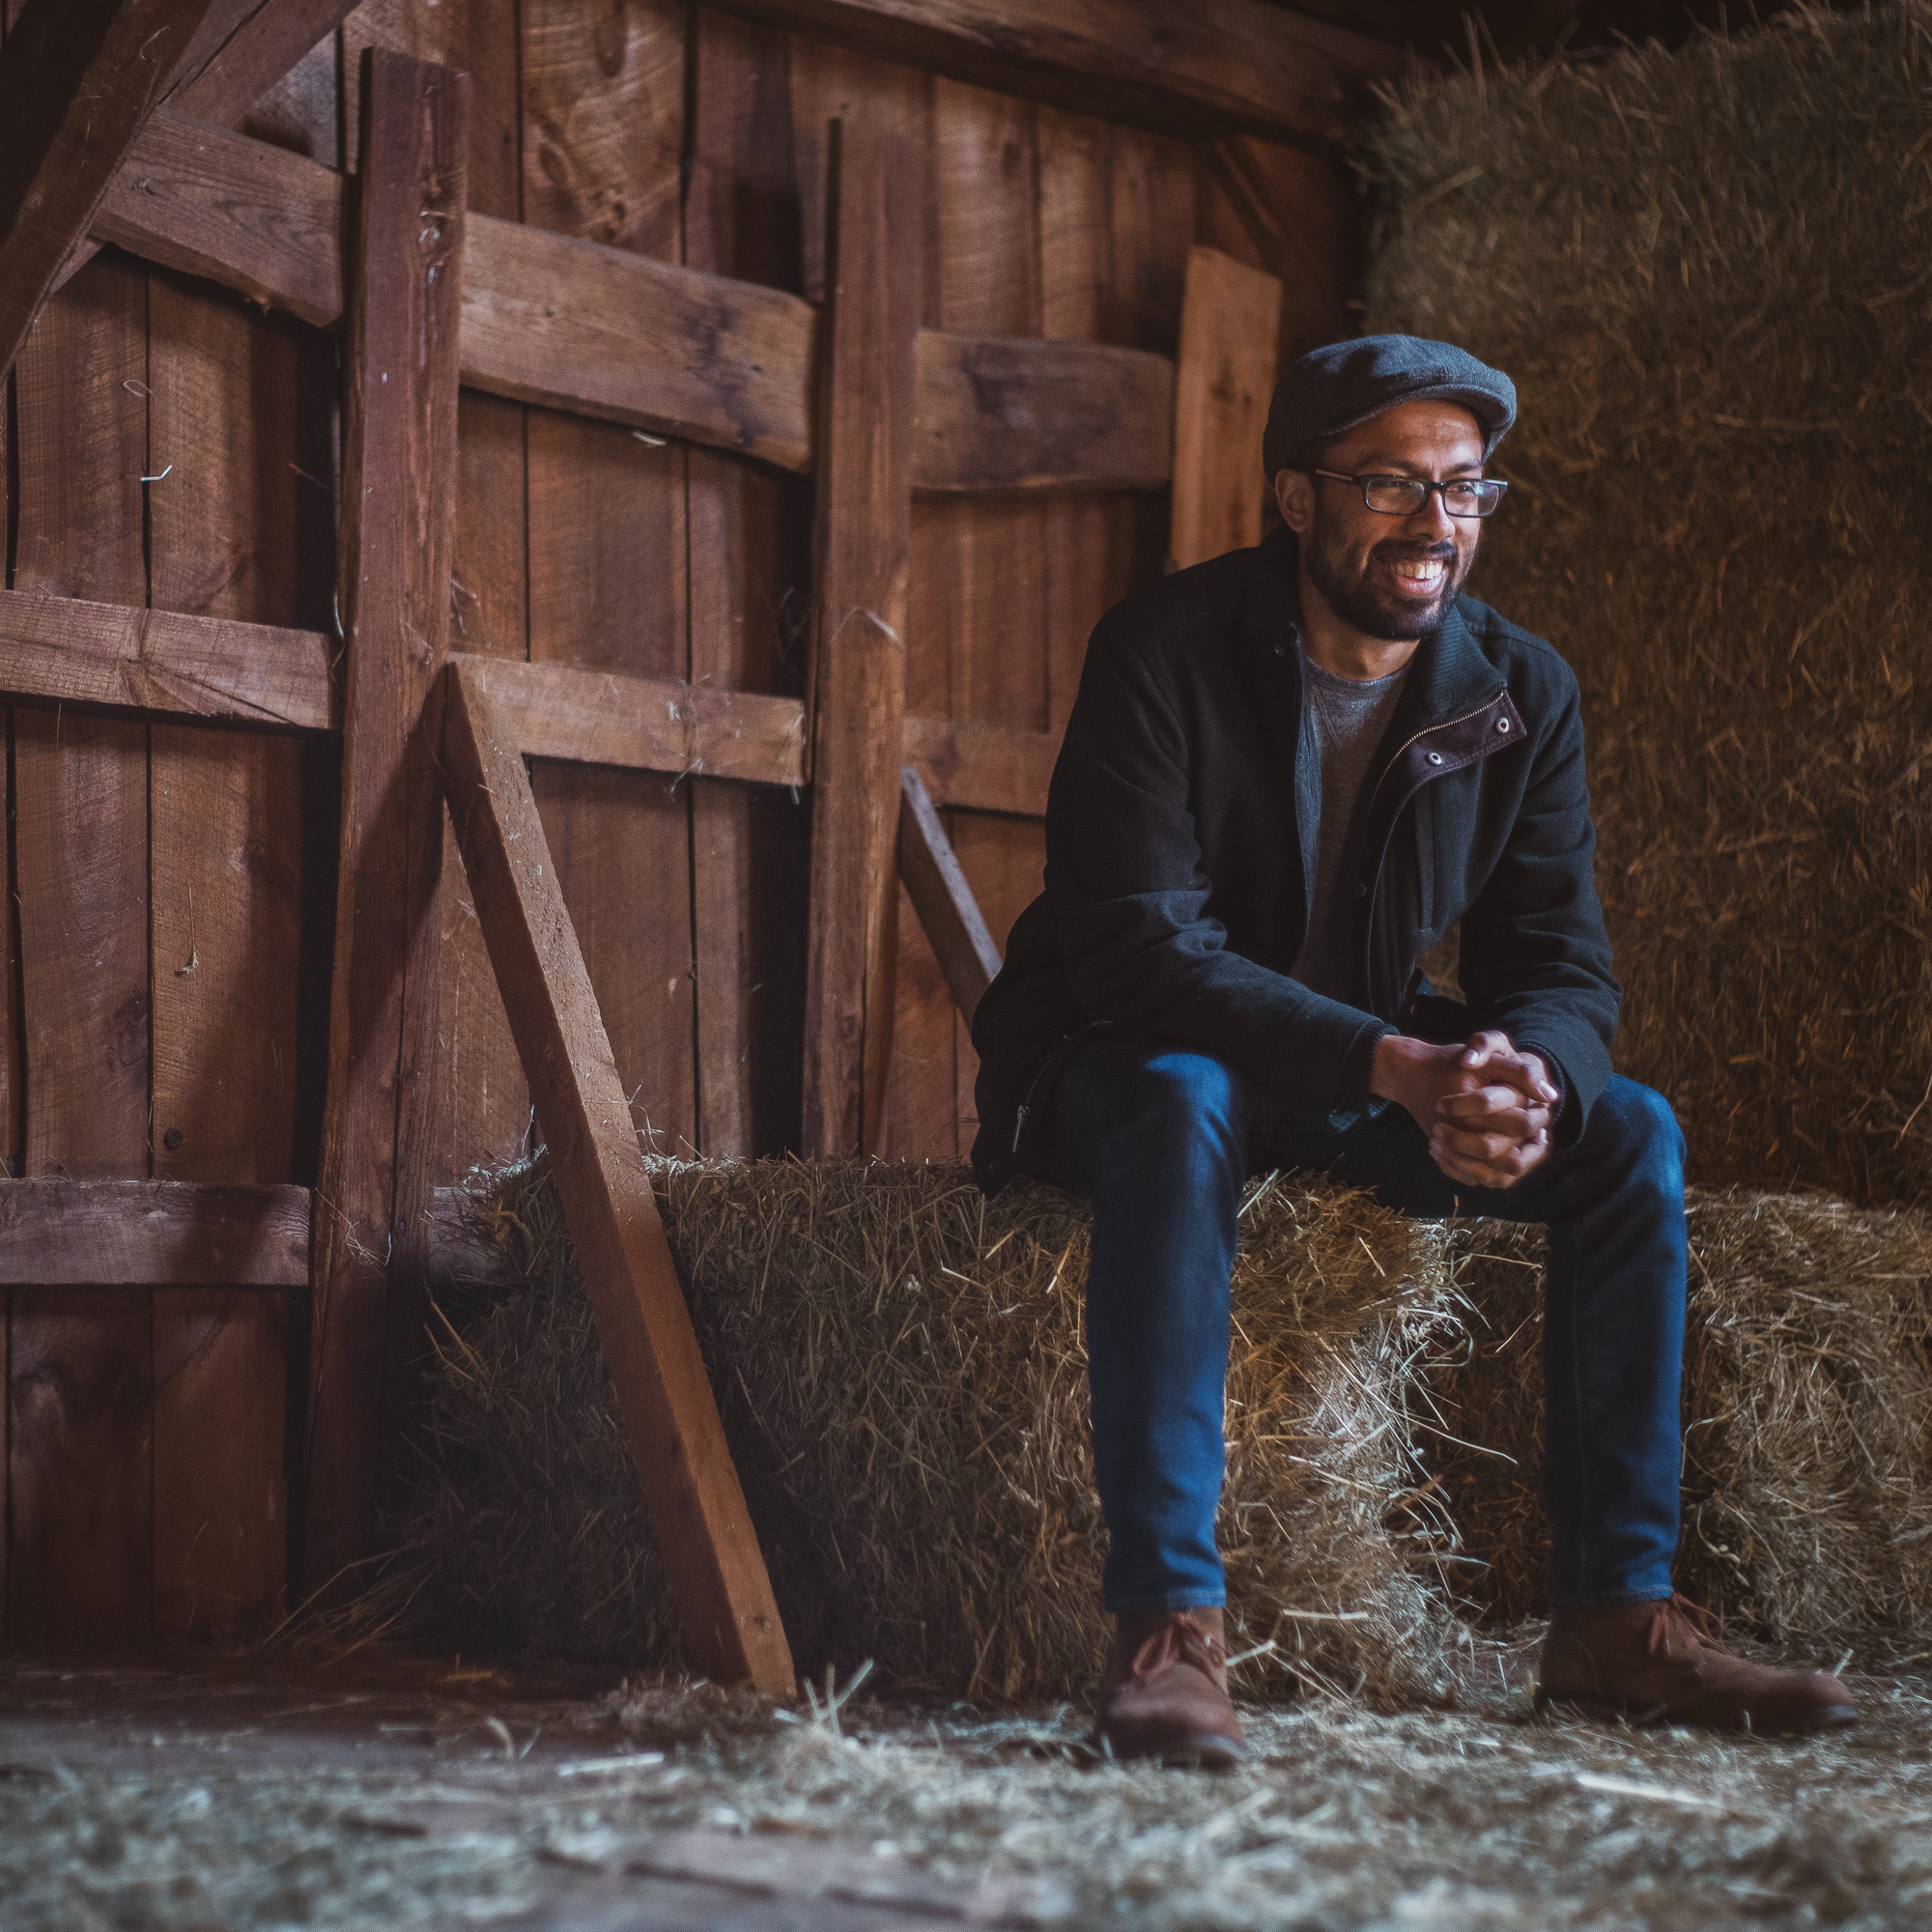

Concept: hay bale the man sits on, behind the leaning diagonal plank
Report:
left=404, top=1161, right=1459, bottom=1700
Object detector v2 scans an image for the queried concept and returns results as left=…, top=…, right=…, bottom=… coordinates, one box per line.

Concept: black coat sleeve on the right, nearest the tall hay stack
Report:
left=1461, top=670, right=1623, bottom=1146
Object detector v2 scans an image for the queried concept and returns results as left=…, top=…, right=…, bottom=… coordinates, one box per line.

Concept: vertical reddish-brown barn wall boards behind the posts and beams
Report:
left=0, top=0, right=1356, bottom=1642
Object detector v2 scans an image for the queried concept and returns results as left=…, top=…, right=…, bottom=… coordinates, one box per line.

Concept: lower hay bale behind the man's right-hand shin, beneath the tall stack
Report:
left=1422, top=1192, right=1932, bottom=1640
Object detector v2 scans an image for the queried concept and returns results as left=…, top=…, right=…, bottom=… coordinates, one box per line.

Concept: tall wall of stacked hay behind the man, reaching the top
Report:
left=1368, top=4, right=1932, bottom=1200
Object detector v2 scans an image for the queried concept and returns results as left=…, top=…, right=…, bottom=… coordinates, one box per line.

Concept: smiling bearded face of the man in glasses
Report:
left=1275, top=402, right=1482, bottom=643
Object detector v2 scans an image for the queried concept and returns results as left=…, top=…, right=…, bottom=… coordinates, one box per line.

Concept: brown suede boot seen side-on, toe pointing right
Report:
left=1536, top=1596, right=1859, bottom=1737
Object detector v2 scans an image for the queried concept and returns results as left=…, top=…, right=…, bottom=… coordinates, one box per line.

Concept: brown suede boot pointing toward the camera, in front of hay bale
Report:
left=1088, top=1609, right=1248, bottom=1772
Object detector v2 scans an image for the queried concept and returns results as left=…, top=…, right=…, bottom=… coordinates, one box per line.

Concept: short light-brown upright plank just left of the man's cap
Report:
left=1169, top=247, right=1281, bottom=568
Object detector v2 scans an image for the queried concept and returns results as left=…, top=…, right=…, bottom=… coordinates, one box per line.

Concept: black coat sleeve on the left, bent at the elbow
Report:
left=1047, top=624, right=1393, bottom=1130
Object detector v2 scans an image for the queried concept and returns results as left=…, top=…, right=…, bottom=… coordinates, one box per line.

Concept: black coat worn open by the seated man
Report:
left=974, top=529, right=1621, bottom=1188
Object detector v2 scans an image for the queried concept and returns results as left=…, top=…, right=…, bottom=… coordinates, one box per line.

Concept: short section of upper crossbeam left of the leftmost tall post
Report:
left=89, top=108, right=342, bottom=328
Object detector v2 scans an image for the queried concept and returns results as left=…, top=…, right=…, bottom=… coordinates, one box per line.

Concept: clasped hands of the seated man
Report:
left=1368, top=1032, right=1563, bottom=1188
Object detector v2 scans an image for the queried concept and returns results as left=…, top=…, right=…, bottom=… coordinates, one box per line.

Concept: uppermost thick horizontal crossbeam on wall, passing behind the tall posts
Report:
left=93, top=110, right=1175, bottom=493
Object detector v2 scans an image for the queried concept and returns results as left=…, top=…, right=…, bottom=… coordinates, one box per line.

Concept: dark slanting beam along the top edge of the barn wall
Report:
left=719, top=0, right=1406, bottom=145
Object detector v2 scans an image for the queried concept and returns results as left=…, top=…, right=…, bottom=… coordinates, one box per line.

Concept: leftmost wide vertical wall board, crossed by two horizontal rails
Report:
left=8, top=261, right=153, bottom=1642
